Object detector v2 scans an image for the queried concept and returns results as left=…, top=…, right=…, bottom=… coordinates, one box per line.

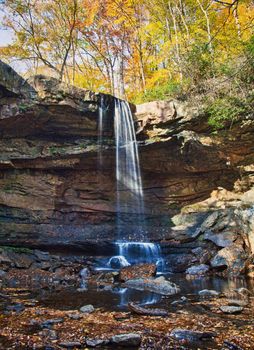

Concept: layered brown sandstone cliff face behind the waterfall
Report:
left=0, top=63, right=254, bottom=276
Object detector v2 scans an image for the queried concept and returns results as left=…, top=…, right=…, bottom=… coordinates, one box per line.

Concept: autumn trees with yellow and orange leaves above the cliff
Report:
left=0, top=0, right=254, bottom=102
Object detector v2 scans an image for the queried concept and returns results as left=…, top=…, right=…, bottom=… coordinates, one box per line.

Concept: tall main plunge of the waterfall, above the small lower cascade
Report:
left=114, top=99, right=146, bottom=241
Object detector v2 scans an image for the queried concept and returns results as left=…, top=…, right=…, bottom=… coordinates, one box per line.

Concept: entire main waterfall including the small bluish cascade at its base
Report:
left=108, top=99, right=164, bottom=272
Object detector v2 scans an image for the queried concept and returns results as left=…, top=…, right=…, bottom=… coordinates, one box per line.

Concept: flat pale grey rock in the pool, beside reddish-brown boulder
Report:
left=125, top=276, right=180, bottom=295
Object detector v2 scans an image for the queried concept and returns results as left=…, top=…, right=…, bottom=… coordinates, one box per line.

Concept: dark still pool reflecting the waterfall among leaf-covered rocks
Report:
left=32, top=275, right=254, bottom=311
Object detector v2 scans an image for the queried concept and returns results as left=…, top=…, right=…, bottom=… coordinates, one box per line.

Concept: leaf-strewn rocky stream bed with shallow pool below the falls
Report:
left=0, top=248, right=254, bottom=350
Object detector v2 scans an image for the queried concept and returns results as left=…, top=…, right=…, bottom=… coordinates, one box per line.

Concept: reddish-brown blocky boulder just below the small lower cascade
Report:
left=119, top=264, right=156, bottom=282
